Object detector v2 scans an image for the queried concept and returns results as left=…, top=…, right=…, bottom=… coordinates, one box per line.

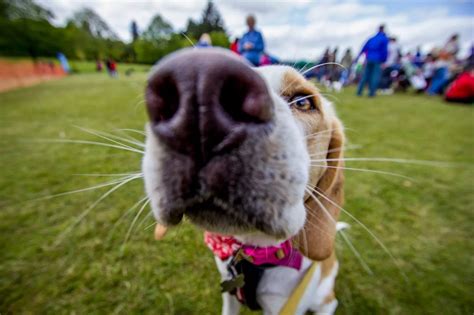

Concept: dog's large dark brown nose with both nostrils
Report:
left=146, top=48, right=273, bottom=162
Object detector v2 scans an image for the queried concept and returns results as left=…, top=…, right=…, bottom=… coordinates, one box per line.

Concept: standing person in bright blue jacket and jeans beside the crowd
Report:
left=356, top=25, right=388, bottom=97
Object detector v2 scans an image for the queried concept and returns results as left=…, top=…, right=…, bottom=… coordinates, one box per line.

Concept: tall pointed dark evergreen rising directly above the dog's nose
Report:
left=186, top=1, right=225, bottom=39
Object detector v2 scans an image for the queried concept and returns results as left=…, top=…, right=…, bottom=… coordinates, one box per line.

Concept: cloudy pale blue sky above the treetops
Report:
left=38, top=0, right=474, bottom=60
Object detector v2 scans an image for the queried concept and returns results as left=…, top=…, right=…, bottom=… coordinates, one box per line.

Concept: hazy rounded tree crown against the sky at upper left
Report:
left=70, top=8, right=119, bottom=40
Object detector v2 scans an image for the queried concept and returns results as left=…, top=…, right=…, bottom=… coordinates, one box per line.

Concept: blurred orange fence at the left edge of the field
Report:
left=0, top=59, right=66, bottom=92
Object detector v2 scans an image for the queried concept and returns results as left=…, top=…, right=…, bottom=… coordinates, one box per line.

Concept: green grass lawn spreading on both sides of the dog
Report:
left=0, top=73, right=474, bottom=314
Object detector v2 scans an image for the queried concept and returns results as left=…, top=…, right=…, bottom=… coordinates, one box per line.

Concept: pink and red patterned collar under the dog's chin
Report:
left=204, top=231, right=303, bottom=270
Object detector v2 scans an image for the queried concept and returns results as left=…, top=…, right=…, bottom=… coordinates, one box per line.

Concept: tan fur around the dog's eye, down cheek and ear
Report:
left=281, top=70, right=344, bottom=261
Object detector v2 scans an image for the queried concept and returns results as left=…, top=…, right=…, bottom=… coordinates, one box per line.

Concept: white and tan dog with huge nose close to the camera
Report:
left=142, top=48, right=344, bottom=314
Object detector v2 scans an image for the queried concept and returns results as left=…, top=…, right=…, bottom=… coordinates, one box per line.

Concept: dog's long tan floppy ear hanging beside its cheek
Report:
left=296, top=118, right=344, bottom=260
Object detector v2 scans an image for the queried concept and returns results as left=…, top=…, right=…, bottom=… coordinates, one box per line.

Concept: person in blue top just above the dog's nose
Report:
left=239, top=15, right=265, bottom=67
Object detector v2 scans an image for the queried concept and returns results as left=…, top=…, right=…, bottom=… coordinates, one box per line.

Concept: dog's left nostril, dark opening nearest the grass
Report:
left=145, top=76, right=180, bottom=123
